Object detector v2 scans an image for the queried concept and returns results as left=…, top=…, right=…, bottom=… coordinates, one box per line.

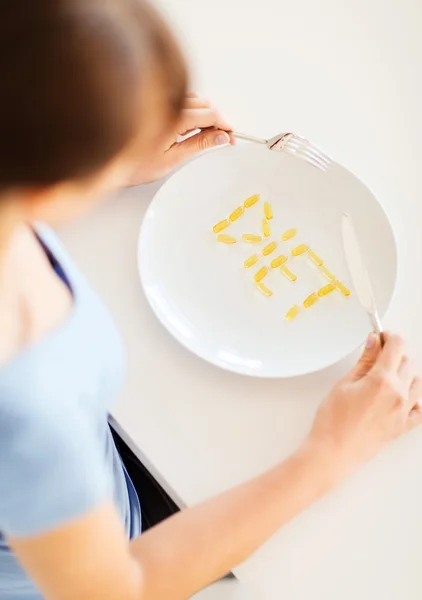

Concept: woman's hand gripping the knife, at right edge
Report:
left=305, top=334, right=422, bottom=477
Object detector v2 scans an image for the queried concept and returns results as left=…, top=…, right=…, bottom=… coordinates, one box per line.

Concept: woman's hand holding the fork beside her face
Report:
left=128, top=93, right=235, bottom=186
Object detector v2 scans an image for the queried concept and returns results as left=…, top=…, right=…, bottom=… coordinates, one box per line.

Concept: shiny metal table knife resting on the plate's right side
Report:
left=341, top=214, right=385, bottom=345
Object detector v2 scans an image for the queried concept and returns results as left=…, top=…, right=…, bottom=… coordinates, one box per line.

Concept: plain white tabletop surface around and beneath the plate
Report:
left=64, top=0, right=422, bottom=600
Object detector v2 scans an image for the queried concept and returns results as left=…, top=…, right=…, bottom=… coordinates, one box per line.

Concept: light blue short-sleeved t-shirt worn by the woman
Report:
left=0, top=226, right=141, bottom=600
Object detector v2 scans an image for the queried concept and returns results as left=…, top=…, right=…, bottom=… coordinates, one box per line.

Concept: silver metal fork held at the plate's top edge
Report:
left=230, top=131, right=333, bottom=171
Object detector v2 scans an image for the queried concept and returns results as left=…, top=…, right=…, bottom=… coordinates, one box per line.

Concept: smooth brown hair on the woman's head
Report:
left=0, top=0, right=186, bottom=189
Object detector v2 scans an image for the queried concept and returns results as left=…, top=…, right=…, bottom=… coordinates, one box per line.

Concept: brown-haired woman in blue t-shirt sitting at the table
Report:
left=0, top=0, right=422, bottom=600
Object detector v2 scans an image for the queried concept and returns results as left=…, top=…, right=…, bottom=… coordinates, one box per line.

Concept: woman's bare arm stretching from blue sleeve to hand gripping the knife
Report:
left=11, top=336, right=422, bottom=600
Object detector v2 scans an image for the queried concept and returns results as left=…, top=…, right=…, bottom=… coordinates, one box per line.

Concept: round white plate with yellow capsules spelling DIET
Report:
left=139, top=144, right=397, bottom=377
